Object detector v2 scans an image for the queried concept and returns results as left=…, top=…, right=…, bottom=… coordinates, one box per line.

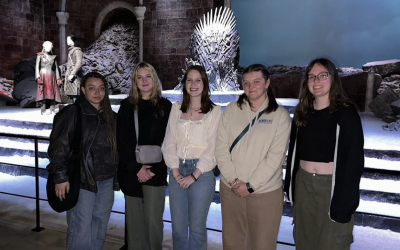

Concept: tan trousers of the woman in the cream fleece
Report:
left=220, top=182, right=284, bottom=250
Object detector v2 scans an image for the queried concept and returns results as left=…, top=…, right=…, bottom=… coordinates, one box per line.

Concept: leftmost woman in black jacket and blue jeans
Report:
left=47, top=72, right=118, bottom=250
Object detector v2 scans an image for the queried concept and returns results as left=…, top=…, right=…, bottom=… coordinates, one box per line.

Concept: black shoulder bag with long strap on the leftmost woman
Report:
left=46, top=104, right=82, bottom=213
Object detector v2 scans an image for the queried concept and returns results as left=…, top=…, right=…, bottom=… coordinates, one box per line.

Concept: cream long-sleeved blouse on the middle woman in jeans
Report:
left=161, top=102, right=222, bottom=173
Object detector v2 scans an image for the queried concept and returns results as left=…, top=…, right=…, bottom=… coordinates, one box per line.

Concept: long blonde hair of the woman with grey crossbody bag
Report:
left=128, top=62, right=164, bottom=117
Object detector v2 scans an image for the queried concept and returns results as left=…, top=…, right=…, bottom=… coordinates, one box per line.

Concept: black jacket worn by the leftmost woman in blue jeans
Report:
left=46, top=97, right=118, bottom=193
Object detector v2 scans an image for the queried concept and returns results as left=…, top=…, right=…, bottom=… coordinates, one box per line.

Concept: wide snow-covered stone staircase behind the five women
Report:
left=0, top=93, right=400, bottom=233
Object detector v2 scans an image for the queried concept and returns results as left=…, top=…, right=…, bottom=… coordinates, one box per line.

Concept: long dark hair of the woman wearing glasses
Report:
left=294, top=58, right=353, bottom=126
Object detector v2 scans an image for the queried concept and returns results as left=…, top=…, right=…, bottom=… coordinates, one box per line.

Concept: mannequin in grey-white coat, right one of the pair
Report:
left=64, top=35, right=82, bottom=102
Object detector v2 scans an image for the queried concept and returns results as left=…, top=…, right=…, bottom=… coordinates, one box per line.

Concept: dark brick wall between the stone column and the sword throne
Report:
left=143, top=0, right=214, bottom=89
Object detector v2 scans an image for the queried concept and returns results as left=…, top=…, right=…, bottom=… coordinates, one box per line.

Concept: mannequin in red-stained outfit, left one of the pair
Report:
left=35, top=41, right=62, bottom=115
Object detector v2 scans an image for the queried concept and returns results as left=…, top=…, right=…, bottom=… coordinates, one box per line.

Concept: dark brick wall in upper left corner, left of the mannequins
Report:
left=0, top=0, right=56, bottom=79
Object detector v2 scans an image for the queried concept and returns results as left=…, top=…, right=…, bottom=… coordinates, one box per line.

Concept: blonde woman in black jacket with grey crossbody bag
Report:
left=117, top=62, right=172, bottom=250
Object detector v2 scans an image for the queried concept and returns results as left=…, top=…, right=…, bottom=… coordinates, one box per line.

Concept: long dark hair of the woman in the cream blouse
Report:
left=181, top=65, right=215, bottom=114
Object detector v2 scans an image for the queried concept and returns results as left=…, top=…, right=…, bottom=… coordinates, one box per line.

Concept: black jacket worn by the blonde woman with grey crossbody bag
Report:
left=117, top=98, right=172, bottom=197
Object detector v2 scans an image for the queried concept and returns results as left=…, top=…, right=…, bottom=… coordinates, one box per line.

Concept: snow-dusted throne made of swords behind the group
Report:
left=175, top=7, right=239, bottom=91
